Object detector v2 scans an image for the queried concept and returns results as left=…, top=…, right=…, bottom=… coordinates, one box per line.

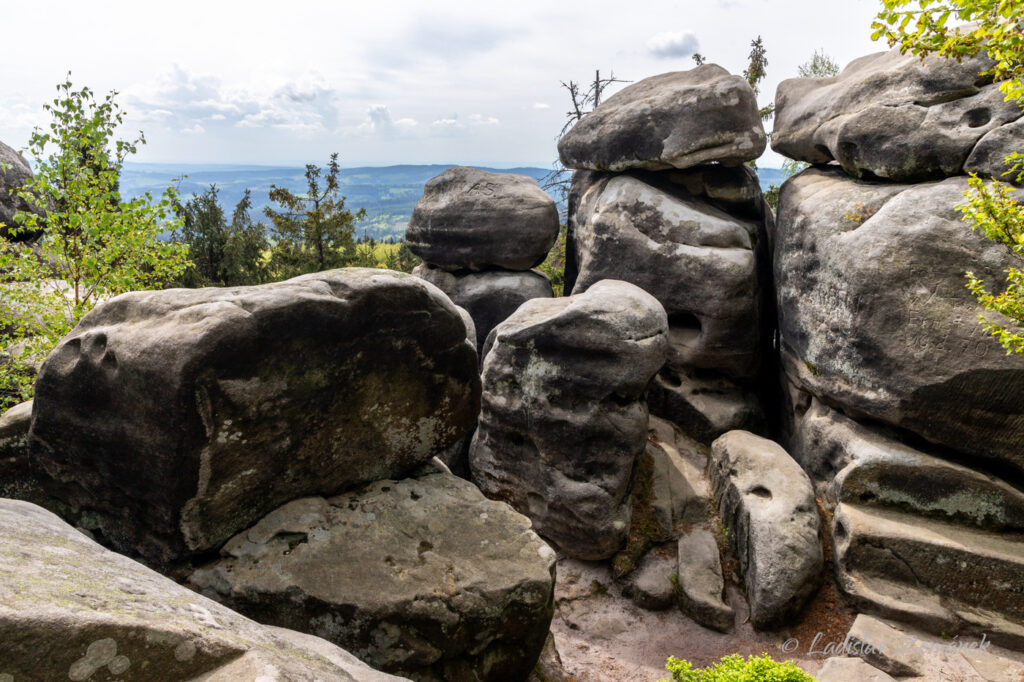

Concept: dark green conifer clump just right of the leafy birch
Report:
left=175, top=185, right=270, bottom=287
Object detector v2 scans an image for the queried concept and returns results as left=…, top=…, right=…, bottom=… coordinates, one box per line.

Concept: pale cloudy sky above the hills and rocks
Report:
left=0, top=0, right=885, bottom=168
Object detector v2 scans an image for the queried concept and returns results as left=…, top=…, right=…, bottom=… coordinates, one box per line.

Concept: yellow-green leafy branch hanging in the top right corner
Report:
left=871, top=0, right=1024, bottom=100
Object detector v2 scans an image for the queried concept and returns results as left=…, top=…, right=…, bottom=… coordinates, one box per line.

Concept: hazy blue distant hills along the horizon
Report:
left=121, top=163, right=782, bottom=240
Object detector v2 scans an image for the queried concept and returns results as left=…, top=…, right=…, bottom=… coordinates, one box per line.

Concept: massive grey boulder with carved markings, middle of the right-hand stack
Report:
left=774, top=169, right=1024, bottom=471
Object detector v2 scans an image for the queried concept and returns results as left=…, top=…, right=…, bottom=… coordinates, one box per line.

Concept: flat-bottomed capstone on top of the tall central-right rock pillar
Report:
left=558, top=65, right=766, bottom=171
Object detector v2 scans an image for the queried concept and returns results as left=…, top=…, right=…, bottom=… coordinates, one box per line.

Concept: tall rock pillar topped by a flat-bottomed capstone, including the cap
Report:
left=558, top=65, right=772, bottom=443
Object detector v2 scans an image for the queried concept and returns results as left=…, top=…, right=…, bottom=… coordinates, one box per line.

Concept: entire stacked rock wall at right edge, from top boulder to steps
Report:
left=772, top=50, right=1024, bottom=645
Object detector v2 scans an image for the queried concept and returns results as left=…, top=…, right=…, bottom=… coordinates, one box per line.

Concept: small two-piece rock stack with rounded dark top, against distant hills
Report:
left=406, top=167, right=558, bottom=352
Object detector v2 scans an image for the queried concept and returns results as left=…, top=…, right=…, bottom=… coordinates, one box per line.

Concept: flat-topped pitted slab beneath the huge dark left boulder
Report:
left=190, top=474, right=555, bottom=680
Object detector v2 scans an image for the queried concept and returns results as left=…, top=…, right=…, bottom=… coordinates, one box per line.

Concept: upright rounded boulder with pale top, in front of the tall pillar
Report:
left=470, top=281, right=668, bottom=559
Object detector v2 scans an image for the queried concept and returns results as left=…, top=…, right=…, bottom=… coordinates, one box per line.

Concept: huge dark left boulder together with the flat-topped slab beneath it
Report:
left=16, top=269, right=554, bottom=680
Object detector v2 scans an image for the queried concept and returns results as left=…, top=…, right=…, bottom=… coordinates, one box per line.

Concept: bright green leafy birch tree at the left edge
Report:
left=0, top=76, right=187, bottom=407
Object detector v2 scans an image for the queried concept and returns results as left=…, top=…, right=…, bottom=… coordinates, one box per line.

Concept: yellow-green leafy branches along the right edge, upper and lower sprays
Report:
left=871, top=0, right=1024, bottom=354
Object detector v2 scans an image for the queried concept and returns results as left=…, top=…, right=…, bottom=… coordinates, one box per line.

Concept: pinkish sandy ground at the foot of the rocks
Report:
left=551, top=559, right=1024, bottom=682
